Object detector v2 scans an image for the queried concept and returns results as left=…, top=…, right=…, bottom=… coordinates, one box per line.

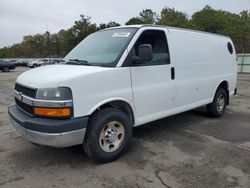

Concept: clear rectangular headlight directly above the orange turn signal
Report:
left=36, top=87, right=72, bottom=100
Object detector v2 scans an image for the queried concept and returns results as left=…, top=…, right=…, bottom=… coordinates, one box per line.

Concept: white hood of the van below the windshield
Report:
left=17, top=65, right=109, bottom=88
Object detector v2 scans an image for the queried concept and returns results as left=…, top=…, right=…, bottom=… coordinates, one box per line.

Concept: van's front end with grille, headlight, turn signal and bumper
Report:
left=8, top=83, right=89, bottom=147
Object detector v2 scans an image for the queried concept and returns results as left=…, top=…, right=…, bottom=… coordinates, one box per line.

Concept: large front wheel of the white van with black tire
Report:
left=83, top=108, right=133, bottom=163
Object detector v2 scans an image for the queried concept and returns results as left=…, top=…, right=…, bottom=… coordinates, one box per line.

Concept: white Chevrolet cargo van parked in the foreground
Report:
left=9, top=25, right=237, bottom=162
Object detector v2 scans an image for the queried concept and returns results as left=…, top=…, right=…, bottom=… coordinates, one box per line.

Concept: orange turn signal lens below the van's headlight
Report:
left=34, top=107, right=71, bottom=117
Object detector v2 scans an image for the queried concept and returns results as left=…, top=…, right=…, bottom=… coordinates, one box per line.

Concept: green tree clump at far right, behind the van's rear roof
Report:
left=190, top=6, right=250, bottom=53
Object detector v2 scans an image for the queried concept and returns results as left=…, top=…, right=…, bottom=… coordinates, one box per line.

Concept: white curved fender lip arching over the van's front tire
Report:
left=88, top=98, right=135, bottom=125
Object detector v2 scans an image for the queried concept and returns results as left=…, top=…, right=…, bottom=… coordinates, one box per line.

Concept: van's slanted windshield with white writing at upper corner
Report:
left=64, top=28, right=137, bottom=67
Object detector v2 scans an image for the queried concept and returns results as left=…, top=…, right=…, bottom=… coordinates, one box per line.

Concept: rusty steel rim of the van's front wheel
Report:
left=99, top=121, right=125, bottom=152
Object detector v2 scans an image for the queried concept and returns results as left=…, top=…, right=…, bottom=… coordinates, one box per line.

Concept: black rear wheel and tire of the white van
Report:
left=207, top=88, right=228, bottom=117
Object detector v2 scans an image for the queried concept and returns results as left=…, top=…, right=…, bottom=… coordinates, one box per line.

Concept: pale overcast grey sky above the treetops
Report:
left=0, top=0, right=250, bottom=48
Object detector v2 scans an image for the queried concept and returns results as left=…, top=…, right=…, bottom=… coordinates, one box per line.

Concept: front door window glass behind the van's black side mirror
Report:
left=134, top=30, right=170, bottom=66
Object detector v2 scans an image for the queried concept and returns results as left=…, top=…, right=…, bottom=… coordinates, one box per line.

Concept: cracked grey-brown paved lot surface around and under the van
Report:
left=0, top=68, right=250, bottom=188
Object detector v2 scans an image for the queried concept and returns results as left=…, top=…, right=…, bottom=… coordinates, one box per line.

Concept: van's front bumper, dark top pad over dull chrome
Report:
left=8, top=105, right=89, bottom=147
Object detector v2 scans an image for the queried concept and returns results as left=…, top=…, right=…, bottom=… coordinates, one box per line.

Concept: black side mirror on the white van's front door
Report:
left=133, top=44, right=153, bottom=64
